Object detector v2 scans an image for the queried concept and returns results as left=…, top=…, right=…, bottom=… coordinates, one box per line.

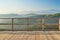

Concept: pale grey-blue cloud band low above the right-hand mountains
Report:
left=21, top=9, right=60, bottom=14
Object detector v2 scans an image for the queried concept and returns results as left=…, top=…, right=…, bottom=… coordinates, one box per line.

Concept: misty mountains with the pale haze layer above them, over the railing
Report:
left=0, top=9, right=60, bottom=18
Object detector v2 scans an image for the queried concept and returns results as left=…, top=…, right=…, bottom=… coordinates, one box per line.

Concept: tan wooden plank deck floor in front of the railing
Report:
left=0, top=31, right=60, bottom=40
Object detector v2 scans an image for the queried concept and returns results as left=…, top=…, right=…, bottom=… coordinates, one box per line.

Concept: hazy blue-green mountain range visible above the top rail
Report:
left=0, top=13, right=60, bottom=18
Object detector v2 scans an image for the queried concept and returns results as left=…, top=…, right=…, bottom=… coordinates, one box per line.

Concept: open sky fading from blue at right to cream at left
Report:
left=0, top=0, right=60, bottom=14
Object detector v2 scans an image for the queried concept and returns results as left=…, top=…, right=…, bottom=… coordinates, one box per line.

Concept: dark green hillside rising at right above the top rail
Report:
left=30, top=13, right=60, bottom=18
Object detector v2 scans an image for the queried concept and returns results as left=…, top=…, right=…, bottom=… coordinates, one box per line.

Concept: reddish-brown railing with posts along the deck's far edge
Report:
left=0, top=18, right=60, bottom=31
